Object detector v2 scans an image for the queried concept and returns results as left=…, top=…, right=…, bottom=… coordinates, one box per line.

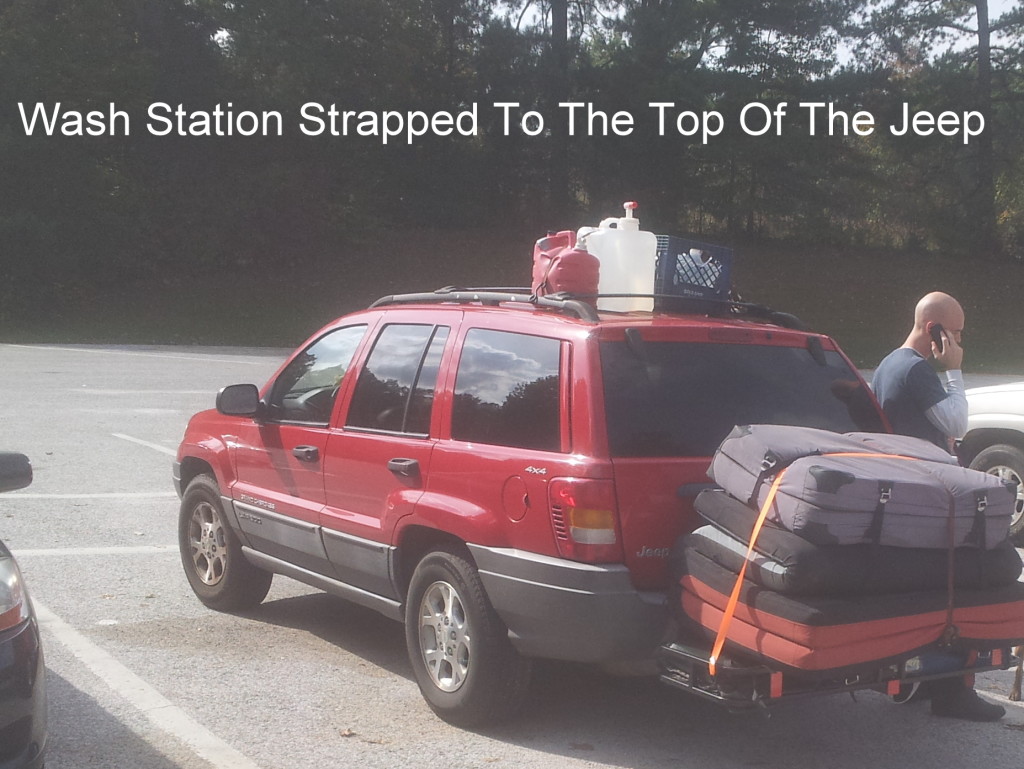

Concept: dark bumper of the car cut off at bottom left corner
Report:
left=0, top=617, right=46, bottom=769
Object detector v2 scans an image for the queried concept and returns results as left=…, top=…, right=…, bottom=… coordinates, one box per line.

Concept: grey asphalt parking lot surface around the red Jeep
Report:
left=0, top=345, right=1024, bottom=769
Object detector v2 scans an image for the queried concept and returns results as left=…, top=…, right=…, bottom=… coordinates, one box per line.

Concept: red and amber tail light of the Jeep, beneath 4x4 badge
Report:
left=548, top=478, right=623, bottom=563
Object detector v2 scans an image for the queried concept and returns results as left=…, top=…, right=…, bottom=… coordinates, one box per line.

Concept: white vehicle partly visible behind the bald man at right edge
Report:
left=958, top=382, right=1024, bottom=547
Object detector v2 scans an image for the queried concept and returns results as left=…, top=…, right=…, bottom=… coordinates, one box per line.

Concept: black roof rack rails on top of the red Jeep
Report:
left=370, top=286, right=808, bottom=331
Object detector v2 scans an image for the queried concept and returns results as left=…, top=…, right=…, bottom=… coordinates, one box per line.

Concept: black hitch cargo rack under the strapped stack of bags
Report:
left=656, top=642, right=1019, bottom=712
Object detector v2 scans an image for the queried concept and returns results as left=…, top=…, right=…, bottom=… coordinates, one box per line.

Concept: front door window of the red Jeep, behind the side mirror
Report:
left=270, top=325, right=367, bottom=424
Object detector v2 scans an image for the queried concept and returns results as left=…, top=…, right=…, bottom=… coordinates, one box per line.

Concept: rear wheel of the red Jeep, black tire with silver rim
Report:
left=406, top=550, right=531, bottom=727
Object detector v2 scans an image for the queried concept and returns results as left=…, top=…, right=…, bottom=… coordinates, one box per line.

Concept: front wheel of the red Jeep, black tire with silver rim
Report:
left=178, top=475, right=273, bottom=611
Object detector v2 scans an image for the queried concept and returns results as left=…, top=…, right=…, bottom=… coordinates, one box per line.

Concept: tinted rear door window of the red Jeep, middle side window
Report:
left=345, top=325, right=449, bottom=435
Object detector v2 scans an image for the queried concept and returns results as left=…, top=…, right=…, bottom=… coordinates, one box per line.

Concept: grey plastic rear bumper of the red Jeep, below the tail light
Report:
left=469, top=545, right=669, bottom=663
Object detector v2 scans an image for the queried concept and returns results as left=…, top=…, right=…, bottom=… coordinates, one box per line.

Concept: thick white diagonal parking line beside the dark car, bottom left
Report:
left=34, top=601, right=259, bottom=769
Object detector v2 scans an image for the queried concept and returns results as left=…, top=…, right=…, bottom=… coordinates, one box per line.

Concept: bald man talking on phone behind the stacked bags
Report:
left=871, top=291, right=1006, bottom=721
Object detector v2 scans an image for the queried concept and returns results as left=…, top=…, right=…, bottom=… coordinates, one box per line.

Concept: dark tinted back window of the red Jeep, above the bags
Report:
left=601, top=342, right=884, bottom=457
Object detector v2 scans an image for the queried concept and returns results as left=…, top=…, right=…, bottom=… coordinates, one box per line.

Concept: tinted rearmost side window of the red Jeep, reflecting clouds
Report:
left=452, top=329, right=561, bottom=452
